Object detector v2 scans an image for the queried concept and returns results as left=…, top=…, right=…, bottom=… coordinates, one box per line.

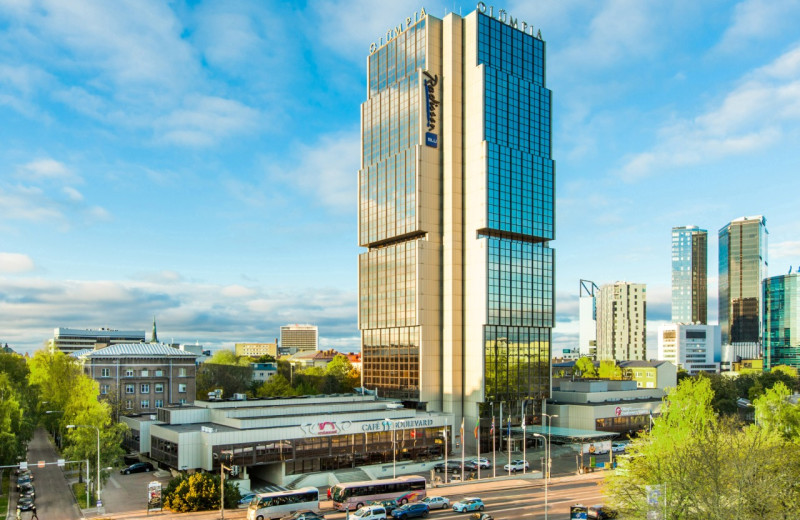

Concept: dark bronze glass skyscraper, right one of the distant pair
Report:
left=719, top=215, right=768, bottom=345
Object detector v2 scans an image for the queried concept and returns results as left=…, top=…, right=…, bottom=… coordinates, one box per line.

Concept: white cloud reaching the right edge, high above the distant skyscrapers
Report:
left=619, top=46, right=800, bottom=181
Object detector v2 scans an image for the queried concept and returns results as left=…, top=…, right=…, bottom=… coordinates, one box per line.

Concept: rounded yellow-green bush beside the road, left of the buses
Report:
left=162, top=473, right=241, bottom=513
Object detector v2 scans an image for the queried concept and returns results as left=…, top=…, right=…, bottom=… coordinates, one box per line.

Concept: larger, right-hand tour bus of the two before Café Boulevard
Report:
left=331, top=475, right=426, bottom=511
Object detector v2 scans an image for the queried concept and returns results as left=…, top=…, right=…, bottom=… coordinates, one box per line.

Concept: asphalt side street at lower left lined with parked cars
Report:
left=9, top=428, right=81, bottom=520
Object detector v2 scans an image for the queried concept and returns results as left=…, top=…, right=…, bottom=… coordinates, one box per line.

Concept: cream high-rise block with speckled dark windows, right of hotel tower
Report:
left=597, top=282, right=647, bottom=361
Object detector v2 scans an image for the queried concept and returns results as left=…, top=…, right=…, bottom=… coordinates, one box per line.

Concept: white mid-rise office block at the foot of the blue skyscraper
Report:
left=658, top=323, right=722, bottom=375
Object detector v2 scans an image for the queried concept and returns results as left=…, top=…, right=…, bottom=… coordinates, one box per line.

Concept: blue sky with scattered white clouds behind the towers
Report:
left=0, top=0, right=800, bottom=353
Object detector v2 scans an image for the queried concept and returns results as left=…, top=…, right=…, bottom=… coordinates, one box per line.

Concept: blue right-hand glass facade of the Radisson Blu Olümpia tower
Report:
left=477, top=13, right=555, bottom=402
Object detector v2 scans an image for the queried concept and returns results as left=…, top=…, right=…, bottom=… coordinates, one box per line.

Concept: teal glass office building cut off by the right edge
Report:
left=763, top=273, right=800, bottom=370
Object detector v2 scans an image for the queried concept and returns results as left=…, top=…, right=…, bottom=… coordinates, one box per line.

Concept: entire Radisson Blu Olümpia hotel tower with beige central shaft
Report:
left=359, top=4, right=554, bottom=442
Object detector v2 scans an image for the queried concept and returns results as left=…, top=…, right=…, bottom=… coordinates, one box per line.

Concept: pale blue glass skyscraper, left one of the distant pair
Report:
left=672, top=226, right=708, bottom=325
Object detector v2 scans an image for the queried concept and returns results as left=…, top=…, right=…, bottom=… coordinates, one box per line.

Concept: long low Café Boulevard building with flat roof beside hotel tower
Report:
left=123, top=394, right=458, bottom=489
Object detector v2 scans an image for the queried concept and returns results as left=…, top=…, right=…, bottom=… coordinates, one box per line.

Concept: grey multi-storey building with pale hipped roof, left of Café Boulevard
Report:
left=73, top=343, right=197, bottom=413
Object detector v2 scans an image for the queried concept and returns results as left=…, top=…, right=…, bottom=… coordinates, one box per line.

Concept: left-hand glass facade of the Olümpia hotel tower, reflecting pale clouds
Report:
left=358, top=18, right=427, bottom=400
